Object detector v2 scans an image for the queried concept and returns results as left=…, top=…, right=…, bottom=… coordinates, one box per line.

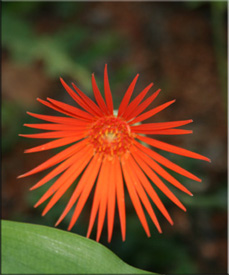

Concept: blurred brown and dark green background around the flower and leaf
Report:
left=2, top=1, right=227, bottom=274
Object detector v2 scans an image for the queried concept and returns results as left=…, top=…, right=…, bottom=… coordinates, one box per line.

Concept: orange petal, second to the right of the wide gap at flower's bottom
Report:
left=127, top=158, right=162, bottom=233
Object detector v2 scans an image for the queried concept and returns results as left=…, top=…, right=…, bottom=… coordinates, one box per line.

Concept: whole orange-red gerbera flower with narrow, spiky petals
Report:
left=19, top=65, right=210, bottom=242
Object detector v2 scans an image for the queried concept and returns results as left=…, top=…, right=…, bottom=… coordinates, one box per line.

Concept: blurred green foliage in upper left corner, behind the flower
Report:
left=2, top=2, right=125, bottom=91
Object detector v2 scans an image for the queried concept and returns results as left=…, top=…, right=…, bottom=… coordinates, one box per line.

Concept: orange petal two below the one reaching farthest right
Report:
left=136, top=150, right=192, bottom=196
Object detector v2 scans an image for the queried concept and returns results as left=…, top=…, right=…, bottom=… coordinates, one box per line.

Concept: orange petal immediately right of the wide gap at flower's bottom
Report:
left=121, top=156, right=150, bottom=237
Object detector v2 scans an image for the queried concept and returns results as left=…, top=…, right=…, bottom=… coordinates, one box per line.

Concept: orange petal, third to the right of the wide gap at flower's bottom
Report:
left=130, top=153, right=173, bottom=225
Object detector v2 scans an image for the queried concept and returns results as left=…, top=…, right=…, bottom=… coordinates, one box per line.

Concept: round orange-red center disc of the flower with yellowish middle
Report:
left=89, top=116, right=133, bottom=157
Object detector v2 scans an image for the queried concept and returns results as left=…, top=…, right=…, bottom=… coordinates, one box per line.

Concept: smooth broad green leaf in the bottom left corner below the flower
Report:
left=2, top=220, right=155, bottom=274
